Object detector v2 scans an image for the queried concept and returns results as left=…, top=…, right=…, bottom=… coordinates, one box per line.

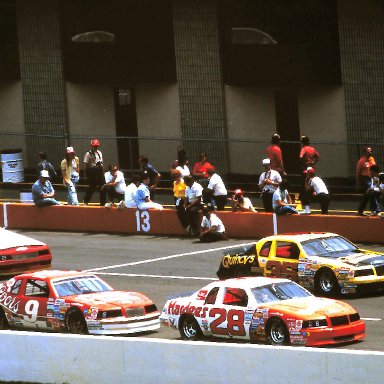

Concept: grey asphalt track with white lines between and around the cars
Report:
left=3, top=230, right=384, bottom=351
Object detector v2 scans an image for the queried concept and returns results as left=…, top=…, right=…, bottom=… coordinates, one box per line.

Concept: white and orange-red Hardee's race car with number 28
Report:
left=160, top=277, right=365, bottom=346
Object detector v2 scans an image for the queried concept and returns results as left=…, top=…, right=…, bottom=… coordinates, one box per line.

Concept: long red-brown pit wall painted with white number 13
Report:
left=0, top=203, right=384, bottom=243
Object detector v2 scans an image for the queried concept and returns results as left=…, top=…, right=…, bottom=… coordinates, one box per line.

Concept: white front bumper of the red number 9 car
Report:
left=87, top=313, right=160, bottom=335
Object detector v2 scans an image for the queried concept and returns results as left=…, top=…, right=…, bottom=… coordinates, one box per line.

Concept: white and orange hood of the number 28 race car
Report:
left=262, top=297, right=356, bottom=319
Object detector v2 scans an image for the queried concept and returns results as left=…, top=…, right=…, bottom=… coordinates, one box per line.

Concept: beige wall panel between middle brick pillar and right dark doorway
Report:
left=225, top=86, right=276, bottom=175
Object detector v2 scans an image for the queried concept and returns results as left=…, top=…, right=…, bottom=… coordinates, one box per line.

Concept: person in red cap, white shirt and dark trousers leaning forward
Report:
left=302, top=167, right=329, bottom=215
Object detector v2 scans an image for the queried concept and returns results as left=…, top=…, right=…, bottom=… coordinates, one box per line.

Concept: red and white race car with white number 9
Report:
left=0, top=270, right=160, bottom=335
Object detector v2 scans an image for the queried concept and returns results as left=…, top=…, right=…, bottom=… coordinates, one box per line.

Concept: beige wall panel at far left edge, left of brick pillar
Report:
left=0, top=81, right=27, bottom=157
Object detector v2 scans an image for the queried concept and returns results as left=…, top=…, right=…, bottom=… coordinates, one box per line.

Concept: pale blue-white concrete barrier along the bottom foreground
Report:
left=0, top=331, right=384, bottom=384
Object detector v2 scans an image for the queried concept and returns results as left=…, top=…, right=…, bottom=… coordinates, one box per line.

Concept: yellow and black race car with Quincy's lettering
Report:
left=217, top=233, right=384, bottom=296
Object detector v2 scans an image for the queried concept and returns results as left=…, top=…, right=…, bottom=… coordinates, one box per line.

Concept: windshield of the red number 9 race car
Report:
left=53, top=276, right=112, bottom=297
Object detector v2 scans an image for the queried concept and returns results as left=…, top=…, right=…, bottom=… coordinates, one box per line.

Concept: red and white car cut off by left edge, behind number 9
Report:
left=0, top=228, right=52, bottom=277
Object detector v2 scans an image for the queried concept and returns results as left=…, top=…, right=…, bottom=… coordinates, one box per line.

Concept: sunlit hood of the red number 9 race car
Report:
left=65, top=291, right=152, bottom=308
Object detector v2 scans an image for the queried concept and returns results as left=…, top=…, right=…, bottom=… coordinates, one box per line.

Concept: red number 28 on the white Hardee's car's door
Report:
left=209, top=308, right=245, bottom=336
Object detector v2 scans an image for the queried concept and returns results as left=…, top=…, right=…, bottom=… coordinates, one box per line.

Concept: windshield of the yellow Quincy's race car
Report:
left=301, top=236, right=359, bottom=257
